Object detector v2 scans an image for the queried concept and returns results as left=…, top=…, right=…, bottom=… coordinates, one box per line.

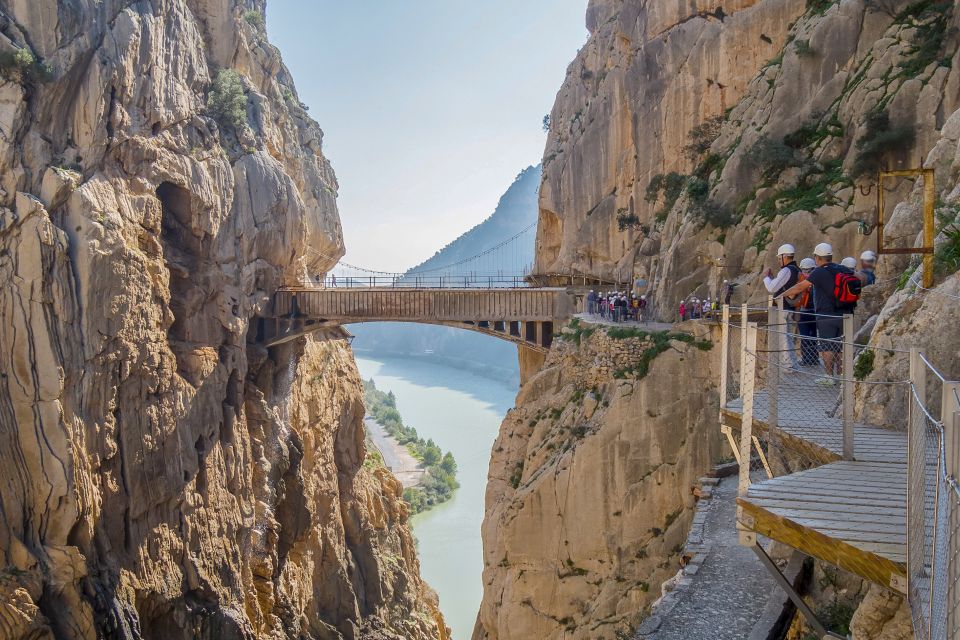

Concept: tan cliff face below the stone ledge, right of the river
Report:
left=473, top=327, right=720, bottom=640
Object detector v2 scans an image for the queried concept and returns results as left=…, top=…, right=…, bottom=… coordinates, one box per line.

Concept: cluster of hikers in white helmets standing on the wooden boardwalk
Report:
left=763, top=242, right=877, bottom=386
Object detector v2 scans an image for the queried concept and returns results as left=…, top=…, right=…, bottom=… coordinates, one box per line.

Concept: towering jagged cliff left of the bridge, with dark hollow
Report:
left=0, top=0, right=444, bottom=639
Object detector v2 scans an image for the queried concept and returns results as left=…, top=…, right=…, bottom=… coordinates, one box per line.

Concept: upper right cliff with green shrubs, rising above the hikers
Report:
left=537, top=0, right=960, bottom=316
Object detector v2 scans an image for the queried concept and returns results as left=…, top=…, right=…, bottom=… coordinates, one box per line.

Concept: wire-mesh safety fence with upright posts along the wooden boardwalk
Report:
left=720, top=306, right=960, bottom=640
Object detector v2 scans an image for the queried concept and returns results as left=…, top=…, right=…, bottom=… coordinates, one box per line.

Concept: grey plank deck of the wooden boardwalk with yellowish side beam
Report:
left=721, top=385, right=907, bottom=593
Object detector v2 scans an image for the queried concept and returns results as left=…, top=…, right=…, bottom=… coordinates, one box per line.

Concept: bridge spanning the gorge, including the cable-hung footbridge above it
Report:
left=258, top=224, right=614, bottom=360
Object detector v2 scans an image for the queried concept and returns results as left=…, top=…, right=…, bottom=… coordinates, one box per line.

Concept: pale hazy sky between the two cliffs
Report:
left=267, top=0, right=587, bottom=271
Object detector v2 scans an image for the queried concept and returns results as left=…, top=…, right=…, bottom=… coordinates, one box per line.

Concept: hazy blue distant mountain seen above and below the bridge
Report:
left=350, top=165, right=541, bottom=384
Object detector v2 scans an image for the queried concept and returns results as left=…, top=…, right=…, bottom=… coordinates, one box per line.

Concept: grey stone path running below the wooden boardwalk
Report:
left=635, top=477, right=777, bottom=640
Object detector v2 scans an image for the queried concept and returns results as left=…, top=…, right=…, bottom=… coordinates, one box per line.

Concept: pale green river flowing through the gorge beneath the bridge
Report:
left=357, top=354, right=517, bottom=640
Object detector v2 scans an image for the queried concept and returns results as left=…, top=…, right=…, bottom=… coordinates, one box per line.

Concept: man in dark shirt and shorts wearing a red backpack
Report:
left=783, top=242, right=863, bottom=386
